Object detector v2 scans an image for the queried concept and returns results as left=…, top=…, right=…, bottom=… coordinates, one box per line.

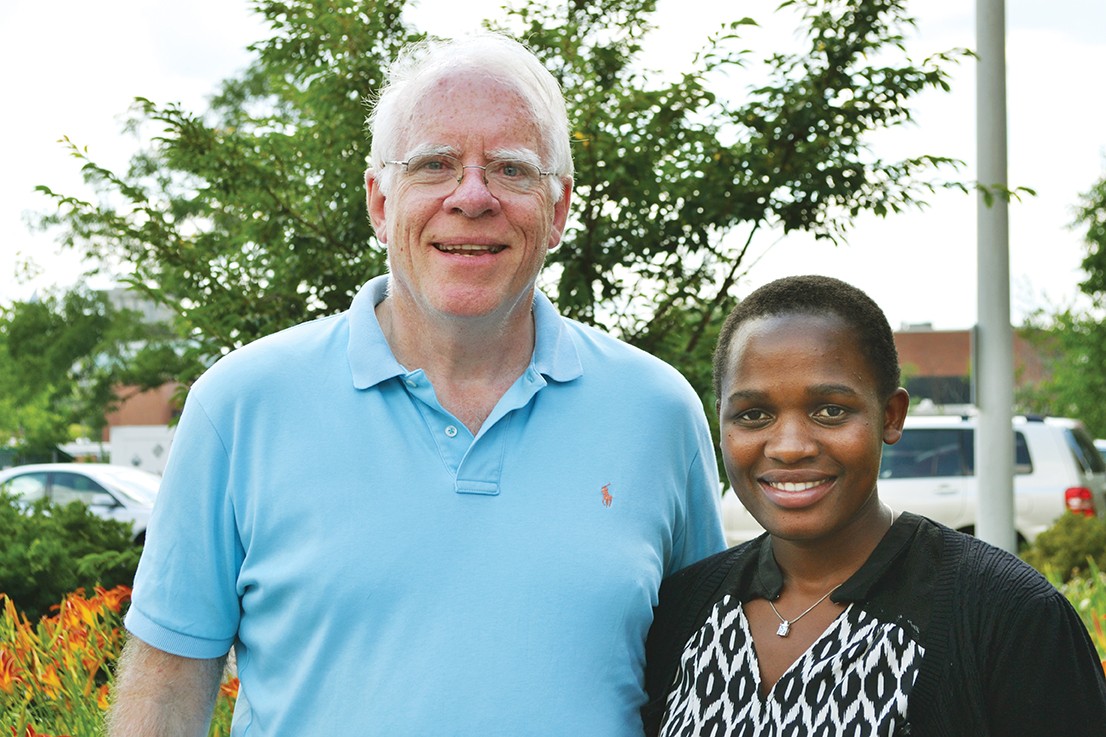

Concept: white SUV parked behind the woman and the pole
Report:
left=722, top=415, right=1106, bottom=544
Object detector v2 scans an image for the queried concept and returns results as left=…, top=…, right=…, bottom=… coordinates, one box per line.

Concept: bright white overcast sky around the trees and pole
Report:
left=0, top=0, right=1106, bottom=329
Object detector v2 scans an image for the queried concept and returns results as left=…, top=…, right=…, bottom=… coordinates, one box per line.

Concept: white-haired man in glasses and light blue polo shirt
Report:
left=111, top=34, right=723, bottom=737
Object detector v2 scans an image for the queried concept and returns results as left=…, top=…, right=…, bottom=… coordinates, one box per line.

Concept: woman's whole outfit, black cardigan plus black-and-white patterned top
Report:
left=641, top=512, right=1106, bottom=737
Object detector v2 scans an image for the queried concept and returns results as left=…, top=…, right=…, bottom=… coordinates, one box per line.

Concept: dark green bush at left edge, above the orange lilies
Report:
left=0, top=495, right=142, bottom=621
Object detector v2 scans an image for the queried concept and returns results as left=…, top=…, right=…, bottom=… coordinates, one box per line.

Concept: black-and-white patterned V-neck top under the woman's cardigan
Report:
left=660, top=595, right=922, bottom=737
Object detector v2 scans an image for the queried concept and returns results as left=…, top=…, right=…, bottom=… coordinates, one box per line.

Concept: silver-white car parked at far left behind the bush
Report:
left=0, top=464, right=161, bottom=544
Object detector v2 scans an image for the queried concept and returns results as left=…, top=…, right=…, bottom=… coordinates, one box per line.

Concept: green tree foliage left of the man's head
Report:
left=42, top=0, right=415, bottom=381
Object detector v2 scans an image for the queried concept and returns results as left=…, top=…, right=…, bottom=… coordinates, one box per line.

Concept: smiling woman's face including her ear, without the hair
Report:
left=719, top=314, right=908, bottom=540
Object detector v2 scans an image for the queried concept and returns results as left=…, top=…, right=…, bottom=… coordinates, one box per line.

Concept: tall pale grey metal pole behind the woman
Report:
left=972, top=0, right=1018, bottom=552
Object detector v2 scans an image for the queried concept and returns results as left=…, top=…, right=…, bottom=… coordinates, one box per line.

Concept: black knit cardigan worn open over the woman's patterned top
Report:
left=641, top=512, right=1106, bottom=737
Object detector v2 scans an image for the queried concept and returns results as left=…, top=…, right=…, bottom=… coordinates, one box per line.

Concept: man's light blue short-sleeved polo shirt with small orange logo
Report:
left=126, top=277, right=724, bottom=737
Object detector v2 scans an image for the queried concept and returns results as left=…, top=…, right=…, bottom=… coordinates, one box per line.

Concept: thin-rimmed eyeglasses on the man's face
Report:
left=384, top=154, right=556, bottom=198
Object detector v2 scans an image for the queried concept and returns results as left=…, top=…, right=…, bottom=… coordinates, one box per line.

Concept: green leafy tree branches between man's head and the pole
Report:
left=499, top=0, right=959, bottom=369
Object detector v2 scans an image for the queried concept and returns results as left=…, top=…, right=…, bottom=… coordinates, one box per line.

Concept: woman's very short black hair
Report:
left=713, top=274, right=900, bottom=399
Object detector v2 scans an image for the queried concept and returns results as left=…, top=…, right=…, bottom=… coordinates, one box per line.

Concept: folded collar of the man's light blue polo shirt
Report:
left=346, top=274, right=584, bottom=390
